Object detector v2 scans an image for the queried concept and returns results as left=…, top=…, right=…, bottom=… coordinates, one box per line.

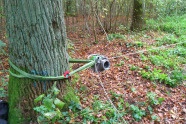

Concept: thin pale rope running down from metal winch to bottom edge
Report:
left=95, top=64, right=127, bottom=124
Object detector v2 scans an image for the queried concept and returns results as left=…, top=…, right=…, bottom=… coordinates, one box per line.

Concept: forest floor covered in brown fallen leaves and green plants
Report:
left=0, top=26, right=186, bottom=124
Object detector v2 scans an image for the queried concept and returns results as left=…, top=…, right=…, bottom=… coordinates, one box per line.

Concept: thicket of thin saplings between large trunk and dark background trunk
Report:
left=63, top=0, right=133, bottom=34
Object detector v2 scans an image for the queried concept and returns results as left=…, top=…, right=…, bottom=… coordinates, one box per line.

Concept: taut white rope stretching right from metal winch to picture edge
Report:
left=108, top=41, right=186, bottom=59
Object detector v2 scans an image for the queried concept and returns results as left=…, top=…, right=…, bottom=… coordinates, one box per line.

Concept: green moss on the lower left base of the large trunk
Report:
left=8, top=69, right=33, bottom=124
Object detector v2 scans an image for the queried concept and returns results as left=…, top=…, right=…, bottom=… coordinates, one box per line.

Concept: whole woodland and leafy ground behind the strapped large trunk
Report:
left=0, top=0, right=186, bottom=124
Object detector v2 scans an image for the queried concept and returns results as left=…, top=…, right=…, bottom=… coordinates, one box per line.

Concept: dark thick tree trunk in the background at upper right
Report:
left=131, top=0, right=144, bottom=30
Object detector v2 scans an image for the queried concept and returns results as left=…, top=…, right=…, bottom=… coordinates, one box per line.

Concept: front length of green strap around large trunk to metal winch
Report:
left=8, top=60, right=95, bottom=80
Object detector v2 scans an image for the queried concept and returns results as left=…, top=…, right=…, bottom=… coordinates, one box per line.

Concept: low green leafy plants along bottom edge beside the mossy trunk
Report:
left=34, top=81, right=165, bottom=124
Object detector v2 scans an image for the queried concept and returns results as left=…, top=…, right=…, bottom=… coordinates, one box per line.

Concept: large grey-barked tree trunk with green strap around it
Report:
left=5, top=0, right=78, bottom=124
